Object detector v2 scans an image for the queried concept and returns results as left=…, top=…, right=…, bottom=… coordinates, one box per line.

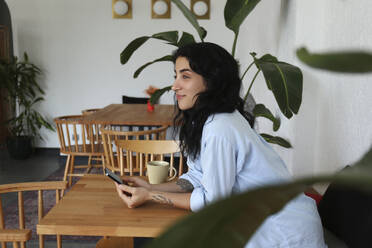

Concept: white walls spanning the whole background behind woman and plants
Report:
left=3, top=0, right=372, bottom=176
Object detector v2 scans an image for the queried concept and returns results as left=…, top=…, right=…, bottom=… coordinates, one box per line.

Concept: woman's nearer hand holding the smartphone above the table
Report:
left=115, top=181, right=150, bottom=208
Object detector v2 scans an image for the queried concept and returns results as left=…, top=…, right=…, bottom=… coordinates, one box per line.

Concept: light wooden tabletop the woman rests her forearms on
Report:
left=37, top=174, right=190, bottom=237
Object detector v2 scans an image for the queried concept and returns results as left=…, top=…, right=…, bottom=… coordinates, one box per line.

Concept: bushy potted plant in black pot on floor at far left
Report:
left=0, top=53, right=54, bottom=159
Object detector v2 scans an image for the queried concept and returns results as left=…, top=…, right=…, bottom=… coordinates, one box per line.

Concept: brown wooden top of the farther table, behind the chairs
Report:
left=84, top=104, right=174, bottom=126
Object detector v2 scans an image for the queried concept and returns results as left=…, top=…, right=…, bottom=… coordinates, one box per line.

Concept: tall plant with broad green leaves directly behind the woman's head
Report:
left=120, top=0, right=302, bottom=148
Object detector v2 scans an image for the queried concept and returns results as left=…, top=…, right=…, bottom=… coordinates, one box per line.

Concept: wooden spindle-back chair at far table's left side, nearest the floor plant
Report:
left=54, top=115, right=104, bottom=185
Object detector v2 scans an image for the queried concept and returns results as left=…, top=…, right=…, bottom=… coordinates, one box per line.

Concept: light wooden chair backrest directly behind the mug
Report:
left=116, top=140, right=183, bottom=176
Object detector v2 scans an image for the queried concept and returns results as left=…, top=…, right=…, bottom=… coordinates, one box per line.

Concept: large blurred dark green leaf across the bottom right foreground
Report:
left=146, top=146, right=372, bottom=248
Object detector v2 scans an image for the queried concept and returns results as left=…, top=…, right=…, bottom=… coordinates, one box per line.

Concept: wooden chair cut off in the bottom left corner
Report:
left=0, top=181, right=67, bottom=248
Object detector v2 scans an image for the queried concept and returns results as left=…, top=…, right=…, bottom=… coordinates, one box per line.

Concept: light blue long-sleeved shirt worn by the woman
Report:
left=181, top=111, right=326, bottom=248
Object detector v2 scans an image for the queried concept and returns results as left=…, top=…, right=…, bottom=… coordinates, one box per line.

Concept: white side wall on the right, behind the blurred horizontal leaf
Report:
left=278, top=0, right=372, bottom=180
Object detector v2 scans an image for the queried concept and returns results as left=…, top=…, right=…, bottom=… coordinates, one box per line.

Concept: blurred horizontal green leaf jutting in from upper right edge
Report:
left=296, top=47, right=372, bottom=73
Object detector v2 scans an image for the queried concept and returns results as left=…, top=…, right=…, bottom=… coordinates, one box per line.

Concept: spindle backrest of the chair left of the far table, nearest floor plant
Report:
left=54, top=115, right=103, bottom=156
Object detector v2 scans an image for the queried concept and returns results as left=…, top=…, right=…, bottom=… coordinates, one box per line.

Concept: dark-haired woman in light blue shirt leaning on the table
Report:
left=117, top=43, right=326, bottom=248
